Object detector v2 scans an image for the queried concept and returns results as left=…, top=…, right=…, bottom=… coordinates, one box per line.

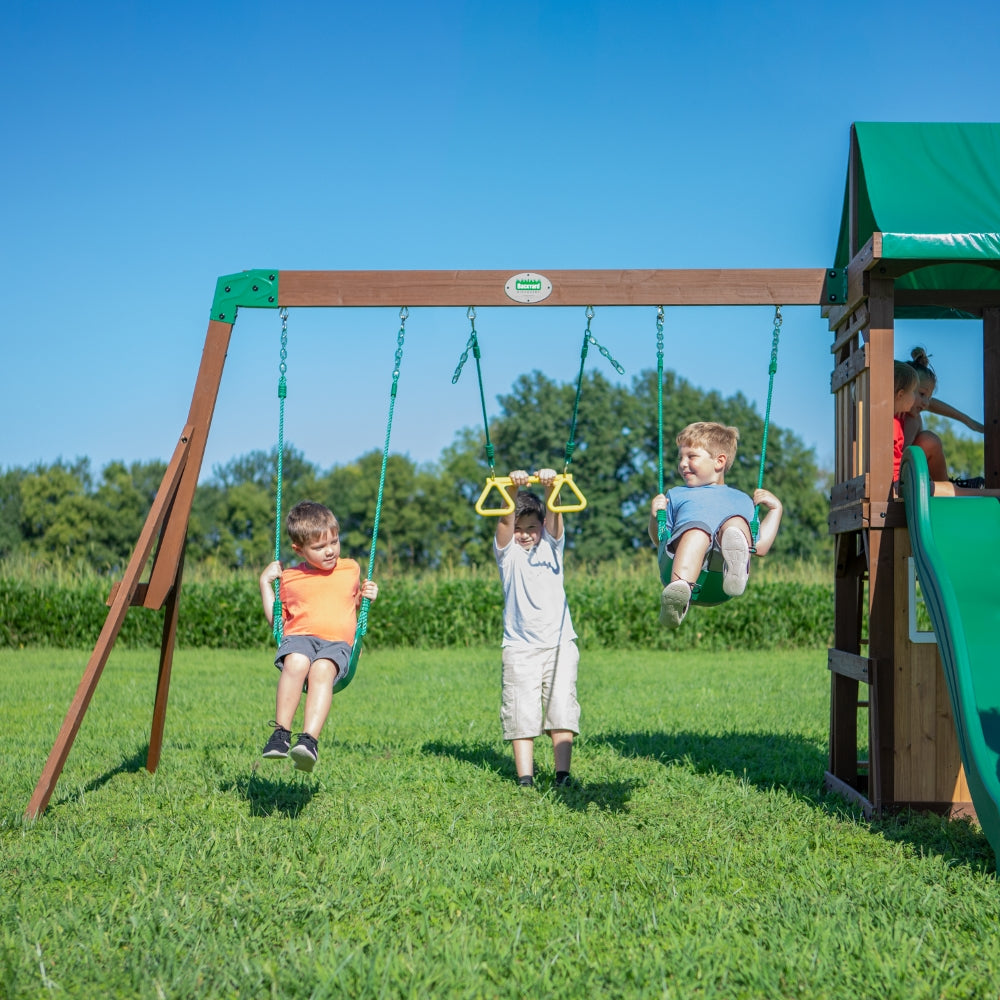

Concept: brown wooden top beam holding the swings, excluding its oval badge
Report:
left=278, top=268, right=826, bottom=307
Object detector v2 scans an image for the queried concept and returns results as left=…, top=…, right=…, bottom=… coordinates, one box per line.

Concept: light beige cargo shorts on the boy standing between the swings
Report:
left=500, top=640, right=580, bottom=740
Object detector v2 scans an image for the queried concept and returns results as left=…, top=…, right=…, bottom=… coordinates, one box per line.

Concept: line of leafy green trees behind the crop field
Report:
left=0, top=370, right=830, bottom=573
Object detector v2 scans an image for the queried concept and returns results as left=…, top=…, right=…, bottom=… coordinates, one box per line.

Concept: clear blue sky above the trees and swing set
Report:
left=0, top=0, right=1000, bottom=484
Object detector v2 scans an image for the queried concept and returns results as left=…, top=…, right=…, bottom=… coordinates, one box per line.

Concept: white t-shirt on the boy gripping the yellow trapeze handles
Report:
left=493, top=527, right=576, bottom=648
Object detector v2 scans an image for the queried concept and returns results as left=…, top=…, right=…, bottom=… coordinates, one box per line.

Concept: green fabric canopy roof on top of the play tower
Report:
left=834, top=122, right=1000, bottom=317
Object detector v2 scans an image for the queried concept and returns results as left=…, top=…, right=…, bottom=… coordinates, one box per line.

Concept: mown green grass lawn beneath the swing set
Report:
left=0, top=649, right=1000, bottom=1000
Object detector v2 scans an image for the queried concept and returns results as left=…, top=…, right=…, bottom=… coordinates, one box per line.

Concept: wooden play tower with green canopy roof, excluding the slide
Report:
left=824, top=122, right=1000, bottom=814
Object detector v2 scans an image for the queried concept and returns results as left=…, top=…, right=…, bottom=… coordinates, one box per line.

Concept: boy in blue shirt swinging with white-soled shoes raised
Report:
left=649, top=421, right=782, bottom=628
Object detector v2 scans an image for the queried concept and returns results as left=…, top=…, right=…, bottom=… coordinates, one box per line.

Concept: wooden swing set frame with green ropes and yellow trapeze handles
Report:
left=26, top=268, right=828, bottom=819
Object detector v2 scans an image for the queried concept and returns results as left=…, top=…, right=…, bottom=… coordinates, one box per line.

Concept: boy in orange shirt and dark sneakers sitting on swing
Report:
left=260, top=500, right=378, bottom=771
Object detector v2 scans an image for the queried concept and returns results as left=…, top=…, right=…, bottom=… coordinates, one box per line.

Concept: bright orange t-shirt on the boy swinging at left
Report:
left=280, top=559, right=361, bottom=642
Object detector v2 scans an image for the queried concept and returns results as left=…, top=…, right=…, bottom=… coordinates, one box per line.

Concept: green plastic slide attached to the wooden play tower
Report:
left=899, top=447, right=1000, bottom=858
